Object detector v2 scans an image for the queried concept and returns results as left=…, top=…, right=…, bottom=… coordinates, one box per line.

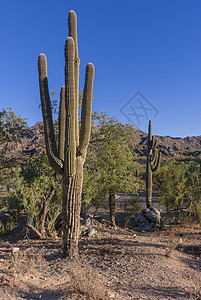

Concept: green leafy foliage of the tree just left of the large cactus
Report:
left=7, top=153, right=61, bottom=231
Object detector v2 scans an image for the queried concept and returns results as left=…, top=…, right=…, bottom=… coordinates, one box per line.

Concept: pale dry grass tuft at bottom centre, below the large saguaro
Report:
left=61, top=263, right=111, bottom=300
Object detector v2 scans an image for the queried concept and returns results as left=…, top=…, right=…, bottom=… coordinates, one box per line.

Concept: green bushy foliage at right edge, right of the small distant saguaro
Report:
left=155, top=160, right=201, bottom=221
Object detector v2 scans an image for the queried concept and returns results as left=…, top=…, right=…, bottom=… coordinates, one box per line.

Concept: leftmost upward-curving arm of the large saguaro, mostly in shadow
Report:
left=38, top=53, right=63, bottom=173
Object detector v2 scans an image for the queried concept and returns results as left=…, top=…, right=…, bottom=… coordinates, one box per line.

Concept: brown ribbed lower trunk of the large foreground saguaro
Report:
left=62, top=156, right=84, bottom=258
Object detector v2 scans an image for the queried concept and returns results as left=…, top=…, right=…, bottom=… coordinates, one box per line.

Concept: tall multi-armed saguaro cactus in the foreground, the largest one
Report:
left=38, top=11, right=94, bottom=257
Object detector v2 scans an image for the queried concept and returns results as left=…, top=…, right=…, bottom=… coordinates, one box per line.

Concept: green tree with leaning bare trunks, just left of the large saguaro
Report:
left=7, top=151, right=61, bottom=238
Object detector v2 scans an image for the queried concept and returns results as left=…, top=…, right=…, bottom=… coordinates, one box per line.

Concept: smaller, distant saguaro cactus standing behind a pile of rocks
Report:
left=146, top=120, right=161, bottom=208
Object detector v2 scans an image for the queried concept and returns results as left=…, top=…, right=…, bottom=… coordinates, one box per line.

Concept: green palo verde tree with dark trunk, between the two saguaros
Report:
left=83, top=112, right=139, bottom=226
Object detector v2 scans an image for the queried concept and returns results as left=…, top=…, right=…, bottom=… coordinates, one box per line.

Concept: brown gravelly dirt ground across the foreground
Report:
left=0, top=221, right=201, bottom=300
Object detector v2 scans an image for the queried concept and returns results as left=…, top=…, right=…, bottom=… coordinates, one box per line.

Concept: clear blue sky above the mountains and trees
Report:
left=0, top=0, right=201, bottom=137
